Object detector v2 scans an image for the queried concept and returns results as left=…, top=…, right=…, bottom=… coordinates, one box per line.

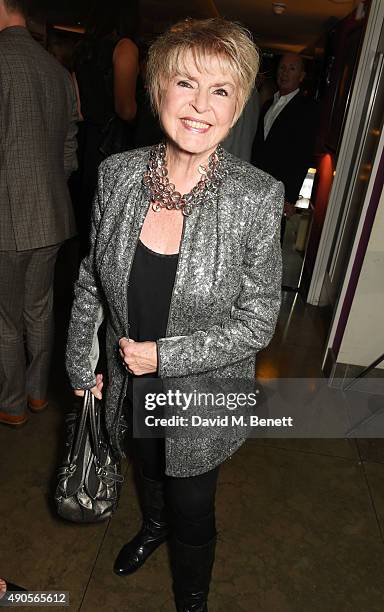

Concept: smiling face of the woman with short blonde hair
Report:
left=159, top=51, right=238, bottom=158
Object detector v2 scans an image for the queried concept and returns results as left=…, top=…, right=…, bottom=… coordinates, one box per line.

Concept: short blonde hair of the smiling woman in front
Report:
left=147, top=17, right=260, bottom=121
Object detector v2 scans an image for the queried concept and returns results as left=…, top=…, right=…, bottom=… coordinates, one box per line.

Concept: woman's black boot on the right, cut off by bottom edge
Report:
left=171, top=537, right=216, bottom=612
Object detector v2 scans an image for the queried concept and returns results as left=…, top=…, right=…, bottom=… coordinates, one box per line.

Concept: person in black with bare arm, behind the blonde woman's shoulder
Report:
left=74, top=0, right=139, bottom=251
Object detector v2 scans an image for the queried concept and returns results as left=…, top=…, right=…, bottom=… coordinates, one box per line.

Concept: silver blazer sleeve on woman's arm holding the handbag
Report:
left=66, top=166, right=104, bottom=389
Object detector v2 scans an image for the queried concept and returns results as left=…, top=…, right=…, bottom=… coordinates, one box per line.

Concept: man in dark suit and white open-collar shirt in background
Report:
left=252, top=53, right=316, bottom=235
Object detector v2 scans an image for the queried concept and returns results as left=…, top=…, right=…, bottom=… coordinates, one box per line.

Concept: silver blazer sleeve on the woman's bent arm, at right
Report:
left=157, top=182, right=284, bottom=378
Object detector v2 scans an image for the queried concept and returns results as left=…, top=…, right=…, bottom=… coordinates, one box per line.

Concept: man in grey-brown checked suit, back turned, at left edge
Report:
left=0, top=0, right=77, bottom=426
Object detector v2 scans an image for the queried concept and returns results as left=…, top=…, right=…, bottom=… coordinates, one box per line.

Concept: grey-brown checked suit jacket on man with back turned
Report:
left=0, top=26, right=77, bottom=251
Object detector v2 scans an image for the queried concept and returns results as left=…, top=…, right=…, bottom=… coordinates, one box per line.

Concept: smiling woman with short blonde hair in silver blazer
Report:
left=67, top=18, right=283, bottom=612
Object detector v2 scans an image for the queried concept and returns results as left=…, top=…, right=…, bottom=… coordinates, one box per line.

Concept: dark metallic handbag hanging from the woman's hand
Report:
left=55, top=390, right=123, bottom=523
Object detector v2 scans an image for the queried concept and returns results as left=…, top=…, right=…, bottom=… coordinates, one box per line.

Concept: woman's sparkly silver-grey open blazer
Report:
left=67, top=148, right=283, bottom=477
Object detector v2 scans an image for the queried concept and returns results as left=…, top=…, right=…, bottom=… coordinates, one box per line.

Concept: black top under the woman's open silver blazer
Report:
left=128, top=241, right=179, bottom=342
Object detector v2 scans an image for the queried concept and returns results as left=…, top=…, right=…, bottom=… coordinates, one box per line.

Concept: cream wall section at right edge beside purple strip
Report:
left=337, top=184, right=384, bottom=369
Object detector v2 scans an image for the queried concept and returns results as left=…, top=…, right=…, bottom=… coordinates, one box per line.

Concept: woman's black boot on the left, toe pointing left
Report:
left=113, top=476, right=168, bottom=576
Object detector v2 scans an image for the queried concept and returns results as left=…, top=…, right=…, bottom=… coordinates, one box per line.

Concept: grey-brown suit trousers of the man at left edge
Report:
left=0, top=245, right=60, bottom=415
